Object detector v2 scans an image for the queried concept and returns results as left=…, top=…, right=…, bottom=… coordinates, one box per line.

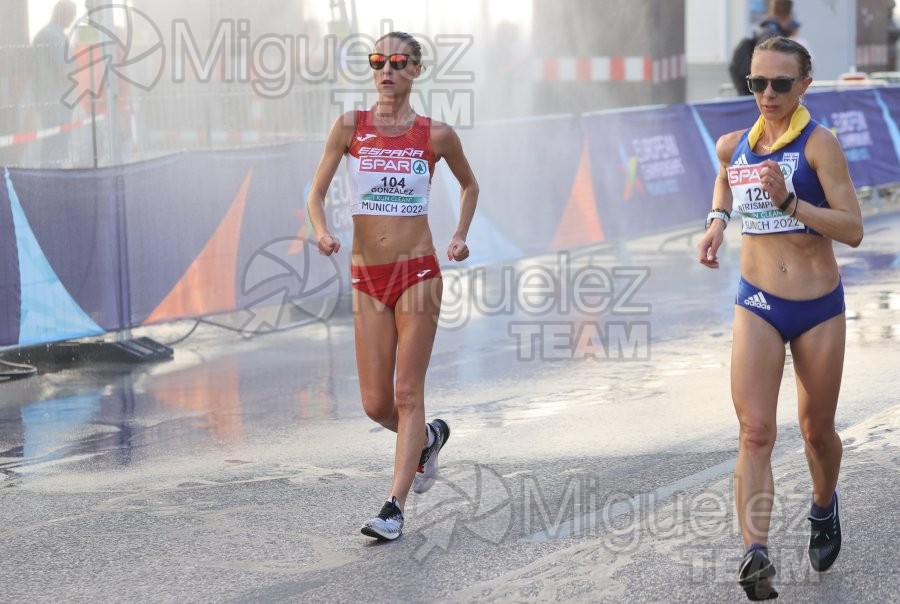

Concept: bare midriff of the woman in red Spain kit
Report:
left=351, top=214, right=434, bottom=265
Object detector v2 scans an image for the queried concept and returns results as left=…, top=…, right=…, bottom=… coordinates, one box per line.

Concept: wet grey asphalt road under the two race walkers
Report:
left=0, top=215, right=900, bottom=602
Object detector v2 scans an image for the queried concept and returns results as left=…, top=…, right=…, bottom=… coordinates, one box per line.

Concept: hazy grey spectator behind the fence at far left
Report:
left=31, top=0, right=75, bottom=168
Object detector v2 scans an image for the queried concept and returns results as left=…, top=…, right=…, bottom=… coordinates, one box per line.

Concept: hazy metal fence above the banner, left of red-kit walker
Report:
left=0, top=37, right=347, bottom=169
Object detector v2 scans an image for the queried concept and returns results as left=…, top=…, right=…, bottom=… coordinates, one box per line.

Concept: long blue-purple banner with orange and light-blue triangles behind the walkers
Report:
left=0, top=88, right=900, bottom=347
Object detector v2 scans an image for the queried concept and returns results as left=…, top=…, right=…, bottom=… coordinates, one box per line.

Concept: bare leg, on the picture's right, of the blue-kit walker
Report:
left=791, top=315, right=846, bottom=508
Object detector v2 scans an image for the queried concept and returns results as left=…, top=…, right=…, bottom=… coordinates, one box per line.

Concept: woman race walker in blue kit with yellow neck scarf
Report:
left=698, top=36, right=863, bottom=600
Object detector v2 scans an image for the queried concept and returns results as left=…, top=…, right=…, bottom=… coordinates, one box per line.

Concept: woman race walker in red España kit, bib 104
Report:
left=307, top=32, right=478, bottom=540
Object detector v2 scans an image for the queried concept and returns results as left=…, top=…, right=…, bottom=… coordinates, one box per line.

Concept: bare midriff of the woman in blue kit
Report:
left=741, top=233, right=840, bottom=300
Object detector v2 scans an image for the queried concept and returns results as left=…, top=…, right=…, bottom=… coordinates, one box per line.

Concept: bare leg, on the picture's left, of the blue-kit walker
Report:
left=731, top=307, right=785, bottom=547
